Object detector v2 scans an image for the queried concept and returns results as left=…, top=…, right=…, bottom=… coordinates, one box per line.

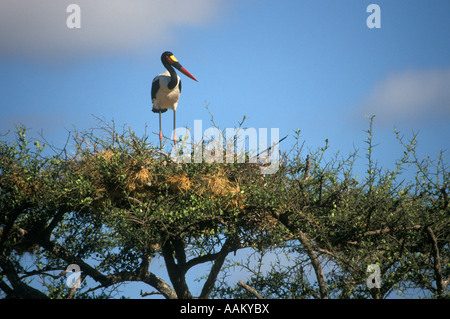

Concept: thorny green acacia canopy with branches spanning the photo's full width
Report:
left=0, top=117, right=450, bottom=298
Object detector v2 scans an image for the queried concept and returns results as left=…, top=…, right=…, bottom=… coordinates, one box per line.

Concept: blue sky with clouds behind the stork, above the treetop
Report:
left=0, top=0, right=450, bottom=298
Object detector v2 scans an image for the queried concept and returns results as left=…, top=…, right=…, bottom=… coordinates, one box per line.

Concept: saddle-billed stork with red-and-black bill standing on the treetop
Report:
left=152, top=51, right=198, bottom=149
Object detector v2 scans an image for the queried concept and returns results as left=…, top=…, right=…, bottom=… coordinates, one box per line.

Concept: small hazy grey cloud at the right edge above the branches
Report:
left=363, top=69, right=450, bottom=124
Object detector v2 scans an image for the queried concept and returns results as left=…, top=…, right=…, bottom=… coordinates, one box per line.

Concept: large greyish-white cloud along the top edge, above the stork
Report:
left=0, top=0, right=224, bottom=58
